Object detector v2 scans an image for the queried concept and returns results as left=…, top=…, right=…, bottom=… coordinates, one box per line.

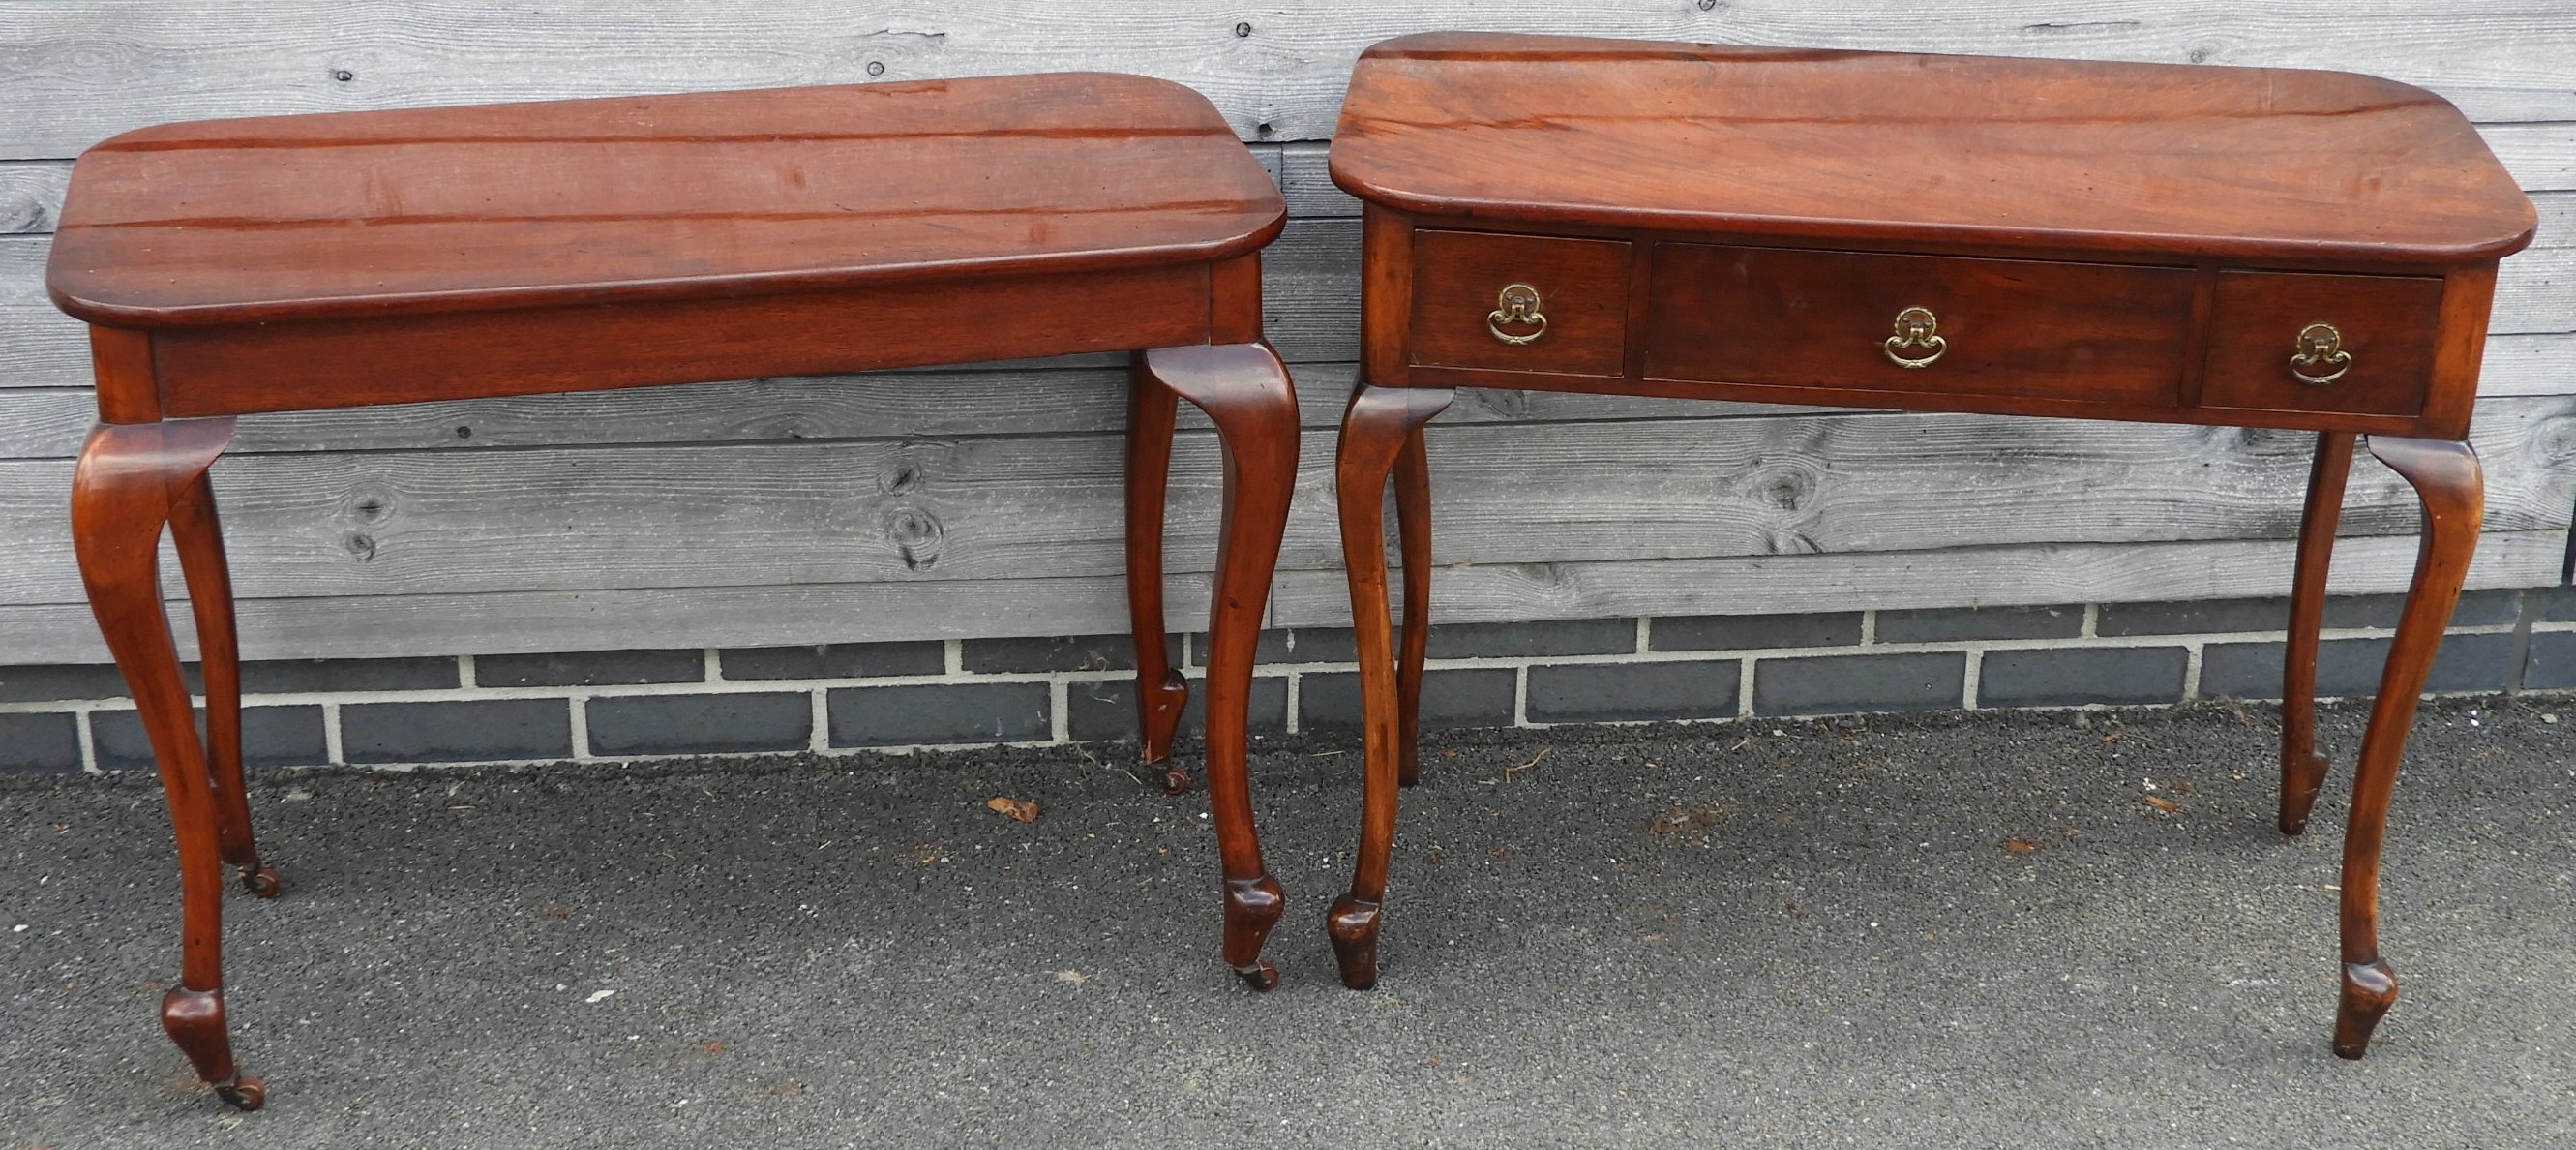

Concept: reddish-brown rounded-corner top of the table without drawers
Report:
left=46, top=75, right=1285, bottom=327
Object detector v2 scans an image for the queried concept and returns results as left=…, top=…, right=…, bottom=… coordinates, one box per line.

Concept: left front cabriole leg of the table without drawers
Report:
left=73, top=418, right=265, bottom=1108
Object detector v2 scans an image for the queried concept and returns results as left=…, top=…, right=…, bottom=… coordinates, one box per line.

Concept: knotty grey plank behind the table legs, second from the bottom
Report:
left=0, top=397, right=2576, bottom=603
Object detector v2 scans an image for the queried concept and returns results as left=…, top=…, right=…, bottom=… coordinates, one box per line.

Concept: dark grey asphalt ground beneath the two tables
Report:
left=0, top=699, right=2576, bottom=1150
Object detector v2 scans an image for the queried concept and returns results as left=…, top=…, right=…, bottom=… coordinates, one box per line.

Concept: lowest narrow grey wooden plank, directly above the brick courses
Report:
left=0, top=531, right=2565, bottom=663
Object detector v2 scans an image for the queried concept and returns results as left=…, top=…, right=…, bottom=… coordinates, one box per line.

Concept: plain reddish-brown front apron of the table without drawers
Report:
left=135, top=263, right=1211, bottom=420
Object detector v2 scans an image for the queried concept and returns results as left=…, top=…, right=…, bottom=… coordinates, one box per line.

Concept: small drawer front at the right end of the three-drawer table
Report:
left=2200, top=271, right=2442, bottom=415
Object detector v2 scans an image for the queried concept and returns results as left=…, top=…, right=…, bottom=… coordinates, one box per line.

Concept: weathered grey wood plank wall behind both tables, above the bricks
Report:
left=0, top=0, right=2576, bottom=663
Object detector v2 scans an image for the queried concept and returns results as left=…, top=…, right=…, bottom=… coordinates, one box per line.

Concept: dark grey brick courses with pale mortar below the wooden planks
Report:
left=0, top=588, right=2576, bottom=771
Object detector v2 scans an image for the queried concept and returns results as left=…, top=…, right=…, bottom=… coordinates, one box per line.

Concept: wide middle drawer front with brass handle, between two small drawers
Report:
left=1646, top=242, right=2195, bottom=405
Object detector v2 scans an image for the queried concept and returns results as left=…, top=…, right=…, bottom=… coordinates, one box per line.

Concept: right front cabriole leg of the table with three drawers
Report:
left=2334, top=436, right=2486, bottom=1057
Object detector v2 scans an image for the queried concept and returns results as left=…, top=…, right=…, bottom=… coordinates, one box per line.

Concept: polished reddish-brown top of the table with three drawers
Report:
left=1332, top=34, right=2534, bottom=265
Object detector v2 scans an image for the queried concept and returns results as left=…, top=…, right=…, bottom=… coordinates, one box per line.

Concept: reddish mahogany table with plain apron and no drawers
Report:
left=46, top=75, right=1299, bottom=1108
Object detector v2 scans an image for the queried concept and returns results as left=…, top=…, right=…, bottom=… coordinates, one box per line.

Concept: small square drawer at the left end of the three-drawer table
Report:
left=1406, top=229, right=1628, bottom=377
